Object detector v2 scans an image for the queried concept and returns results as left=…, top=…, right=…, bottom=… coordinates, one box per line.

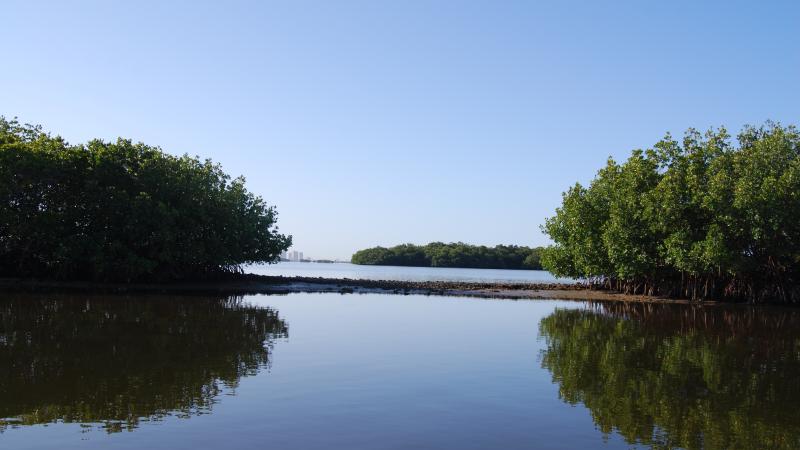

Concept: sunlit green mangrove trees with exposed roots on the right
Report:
left=542, top=122, right=800, bottom=303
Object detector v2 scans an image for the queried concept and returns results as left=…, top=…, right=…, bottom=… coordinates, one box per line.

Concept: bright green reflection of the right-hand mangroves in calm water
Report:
left=540, top=304, right=800, bottom=449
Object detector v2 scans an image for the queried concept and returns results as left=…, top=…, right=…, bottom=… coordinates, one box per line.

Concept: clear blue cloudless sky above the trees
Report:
left=0, top=0, right=800, bottom=258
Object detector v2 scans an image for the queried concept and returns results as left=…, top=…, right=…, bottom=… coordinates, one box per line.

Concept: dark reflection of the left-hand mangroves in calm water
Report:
left=0, top=294, right=287, bottom=432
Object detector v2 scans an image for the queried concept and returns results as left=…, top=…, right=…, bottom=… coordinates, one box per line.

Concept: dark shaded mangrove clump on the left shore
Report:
left=0, top=117, right=291, bottom=281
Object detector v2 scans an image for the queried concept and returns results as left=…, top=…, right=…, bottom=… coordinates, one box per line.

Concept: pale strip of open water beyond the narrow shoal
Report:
left=246, top=262, right=574, bottom=283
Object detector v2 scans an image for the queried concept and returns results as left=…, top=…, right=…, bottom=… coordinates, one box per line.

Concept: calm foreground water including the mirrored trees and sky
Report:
left=0, top=294, right=800, bottom=449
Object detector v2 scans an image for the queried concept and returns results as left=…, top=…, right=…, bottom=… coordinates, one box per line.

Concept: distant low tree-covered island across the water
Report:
left=351, top=242, right=542, bottom=270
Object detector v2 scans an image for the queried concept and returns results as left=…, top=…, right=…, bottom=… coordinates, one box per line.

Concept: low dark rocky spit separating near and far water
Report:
left=0, top=274, right=719, bottom=305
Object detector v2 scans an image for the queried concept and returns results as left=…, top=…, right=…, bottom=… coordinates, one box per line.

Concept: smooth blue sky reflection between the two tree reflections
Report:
left=0, top=294, right=796, bottom=449
